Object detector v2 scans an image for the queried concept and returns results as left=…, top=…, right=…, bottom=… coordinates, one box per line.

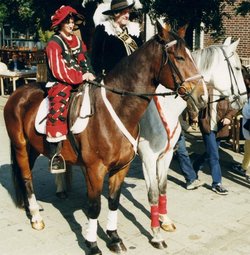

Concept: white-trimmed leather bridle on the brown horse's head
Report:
left=157, top=40, right=202, bottom=99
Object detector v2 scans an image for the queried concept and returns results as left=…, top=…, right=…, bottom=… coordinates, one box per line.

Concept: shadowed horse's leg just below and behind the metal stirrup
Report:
left=55, top=164, right=72, bottom=199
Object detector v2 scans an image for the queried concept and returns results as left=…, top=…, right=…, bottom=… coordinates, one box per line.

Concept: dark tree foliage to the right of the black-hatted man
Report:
left=141, top=0, right=235, bottom=36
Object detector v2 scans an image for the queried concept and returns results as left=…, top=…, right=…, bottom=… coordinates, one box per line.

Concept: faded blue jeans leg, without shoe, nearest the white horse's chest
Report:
left=176, top=133, right=197, bottom=182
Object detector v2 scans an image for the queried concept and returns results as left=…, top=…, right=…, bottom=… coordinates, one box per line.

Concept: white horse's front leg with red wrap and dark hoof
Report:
left=142, top=160, right=167, bottom=249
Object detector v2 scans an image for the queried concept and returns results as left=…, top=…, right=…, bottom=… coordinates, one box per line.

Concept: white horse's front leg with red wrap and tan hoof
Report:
left=157, top=150, right=176, bottom=232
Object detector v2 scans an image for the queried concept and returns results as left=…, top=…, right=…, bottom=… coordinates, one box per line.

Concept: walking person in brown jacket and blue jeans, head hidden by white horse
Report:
left=193, top=88, right=239, bottom=195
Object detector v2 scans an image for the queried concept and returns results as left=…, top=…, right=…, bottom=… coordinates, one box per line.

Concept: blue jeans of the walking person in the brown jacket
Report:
left=193, top=131, right=222, bottom=186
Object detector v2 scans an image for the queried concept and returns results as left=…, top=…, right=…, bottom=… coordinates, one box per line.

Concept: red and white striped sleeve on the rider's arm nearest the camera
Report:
left=46, top=40, right=83, bottom=85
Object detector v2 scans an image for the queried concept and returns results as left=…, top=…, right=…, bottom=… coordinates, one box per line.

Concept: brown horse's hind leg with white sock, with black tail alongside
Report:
left=12, top=143, right=45, bottom=230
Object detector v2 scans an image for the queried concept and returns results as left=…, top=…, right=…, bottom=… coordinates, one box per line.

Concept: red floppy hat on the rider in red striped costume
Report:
left=51, top=5, right=84, bottom=29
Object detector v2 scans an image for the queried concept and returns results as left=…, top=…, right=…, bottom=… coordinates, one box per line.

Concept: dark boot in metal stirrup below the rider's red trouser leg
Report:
left=49, top=142, right=66, bottom=174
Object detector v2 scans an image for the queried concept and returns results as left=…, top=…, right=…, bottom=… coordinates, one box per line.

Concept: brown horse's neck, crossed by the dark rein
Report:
left=105, top=45, right=160, bottom=125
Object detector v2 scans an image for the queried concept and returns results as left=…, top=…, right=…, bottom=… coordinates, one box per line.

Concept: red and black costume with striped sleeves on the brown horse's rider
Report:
left=46, top=32, right=92, bottom=140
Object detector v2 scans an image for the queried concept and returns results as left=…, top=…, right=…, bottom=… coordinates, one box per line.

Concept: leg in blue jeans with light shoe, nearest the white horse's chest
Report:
left=175, top=132, right=204, bottom=190
